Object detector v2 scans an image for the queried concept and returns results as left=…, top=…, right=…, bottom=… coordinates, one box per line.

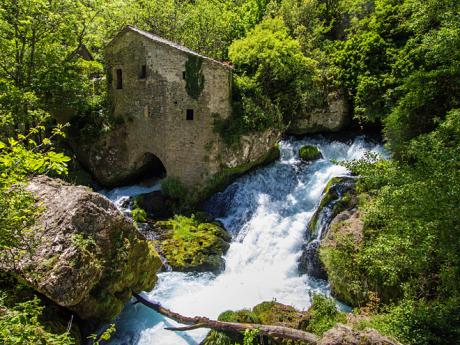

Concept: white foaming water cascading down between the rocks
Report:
left=106, top=137, right=383, bottom=345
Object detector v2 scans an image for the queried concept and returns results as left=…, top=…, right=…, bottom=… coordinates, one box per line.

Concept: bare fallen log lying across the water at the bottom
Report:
left=133, top=293, right=318, bottom=344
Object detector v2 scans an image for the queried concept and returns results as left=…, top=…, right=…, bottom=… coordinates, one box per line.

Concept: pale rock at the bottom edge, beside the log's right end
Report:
left=318, top=324, right=400, bottom=345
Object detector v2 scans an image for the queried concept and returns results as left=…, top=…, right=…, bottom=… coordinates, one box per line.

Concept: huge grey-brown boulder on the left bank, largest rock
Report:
left=7, top=176, right=161, bottom=321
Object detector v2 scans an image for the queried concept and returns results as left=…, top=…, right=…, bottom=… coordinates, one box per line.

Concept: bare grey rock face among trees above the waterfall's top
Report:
left=288, top=92, right=350, bottom=135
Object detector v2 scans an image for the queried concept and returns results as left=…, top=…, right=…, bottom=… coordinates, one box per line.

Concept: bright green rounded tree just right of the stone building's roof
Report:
left=227, top=17, right=319, bottom=137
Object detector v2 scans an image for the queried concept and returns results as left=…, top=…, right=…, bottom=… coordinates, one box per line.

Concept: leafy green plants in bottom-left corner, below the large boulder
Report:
left=0, top=296, right=75, bottom=345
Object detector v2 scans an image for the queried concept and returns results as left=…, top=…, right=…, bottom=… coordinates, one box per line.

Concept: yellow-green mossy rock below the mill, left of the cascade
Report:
left=155, top=216, right=231, bottom=272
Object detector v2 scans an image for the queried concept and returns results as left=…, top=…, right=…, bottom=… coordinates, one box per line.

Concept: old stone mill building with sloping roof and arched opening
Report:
left=106, top=26, right=231, bottom=185
